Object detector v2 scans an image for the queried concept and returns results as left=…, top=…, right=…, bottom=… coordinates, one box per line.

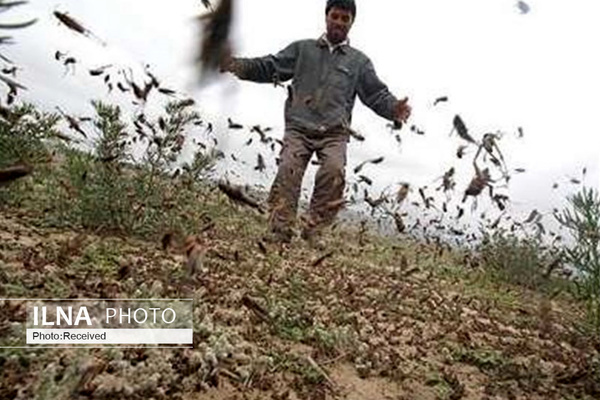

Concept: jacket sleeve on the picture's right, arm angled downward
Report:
left=357, top=59, right=398, bottom=121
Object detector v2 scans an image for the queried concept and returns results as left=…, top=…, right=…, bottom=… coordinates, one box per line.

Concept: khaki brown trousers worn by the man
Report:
left=269, top=129, right=349, bottom=232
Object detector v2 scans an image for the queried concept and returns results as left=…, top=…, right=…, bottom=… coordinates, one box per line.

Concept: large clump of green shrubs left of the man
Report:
left=0, top=102, right=218, bottom=236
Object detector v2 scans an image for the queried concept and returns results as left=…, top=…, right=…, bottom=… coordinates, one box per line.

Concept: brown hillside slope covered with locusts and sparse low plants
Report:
left=0, top=195, right=600, bottom=400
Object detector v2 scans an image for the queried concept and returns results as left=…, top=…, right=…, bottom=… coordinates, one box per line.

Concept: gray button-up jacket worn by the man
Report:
left=235, top=38, right=397, bottom=132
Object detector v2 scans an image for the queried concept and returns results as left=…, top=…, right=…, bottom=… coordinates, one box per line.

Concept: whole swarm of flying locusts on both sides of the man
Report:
left=0, top=0, right=585, bottom=252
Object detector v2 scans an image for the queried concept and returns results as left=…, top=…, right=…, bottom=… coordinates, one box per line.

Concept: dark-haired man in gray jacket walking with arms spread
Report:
left=222, top=0, right=411, bottom=243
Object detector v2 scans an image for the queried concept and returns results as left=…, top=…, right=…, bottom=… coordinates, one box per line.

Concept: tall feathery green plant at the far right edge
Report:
left=555, top=187, right=600, bottom=334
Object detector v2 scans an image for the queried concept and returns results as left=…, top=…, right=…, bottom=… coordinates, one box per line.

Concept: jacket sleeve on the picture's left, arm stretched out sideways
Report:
left=234, top=42, right=300, bottom=83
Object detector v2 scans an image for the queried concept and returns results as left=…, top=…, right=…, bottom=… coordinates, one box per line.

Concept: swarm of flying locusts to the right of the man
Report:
left=342, top=104, right=552, bottom=242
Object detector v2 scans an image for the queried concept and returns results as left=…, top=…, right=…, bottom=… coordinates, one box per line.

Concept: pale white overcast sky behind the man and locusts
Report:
left=3, top=0, right=600, bottom=225
